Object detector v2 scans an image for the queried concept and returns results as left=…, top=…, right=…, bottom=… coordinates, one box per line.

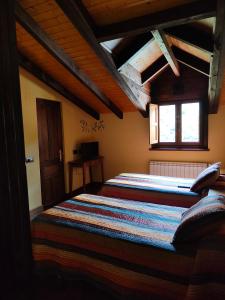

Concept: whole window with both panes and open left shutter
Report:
left=150, top=101, right=208, bottom=150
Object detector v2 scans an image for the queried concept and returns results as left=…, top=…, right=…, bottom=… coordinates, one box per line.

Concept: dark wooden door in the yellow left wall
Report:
left=37, top=99, right=65, bottom=207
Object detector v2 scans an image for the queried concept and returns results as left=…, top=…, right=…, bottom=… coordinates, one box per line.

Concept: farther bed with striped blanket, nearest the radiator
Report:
left=99, top=173, right=203, bottom=207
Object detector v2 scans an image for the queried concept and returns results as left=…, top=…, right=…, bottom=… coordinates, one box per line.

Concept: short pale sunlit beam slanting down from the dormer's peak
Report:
left=152, top=30, right=180, bottom=76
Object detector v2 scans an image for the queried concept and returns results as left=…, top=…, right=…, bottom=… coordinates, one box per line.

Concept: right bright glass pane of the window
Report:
left=181, top=102, right=199, bottom=142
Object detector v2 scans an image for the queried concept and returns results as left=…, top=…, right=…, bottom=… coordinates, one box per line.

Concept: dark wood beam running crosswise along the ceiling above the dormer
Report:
left=95, top=0, right=216, bottom=42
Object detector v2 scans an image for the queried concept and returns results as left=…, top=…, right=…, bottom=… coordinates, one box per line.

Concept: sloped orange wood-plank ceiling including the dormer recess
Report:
left=16, top=0, right=225, bottom=118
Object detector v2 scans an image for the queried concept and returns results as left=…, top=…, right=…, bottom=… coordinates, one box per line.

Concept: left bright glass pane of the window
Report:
left=159, top=105, right=176, bottom=143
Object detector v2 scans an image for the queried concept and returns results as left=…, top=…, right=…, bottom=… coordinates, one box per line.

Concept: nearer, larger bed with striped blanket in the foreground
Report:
left=32, top=194, right=225, bottom=300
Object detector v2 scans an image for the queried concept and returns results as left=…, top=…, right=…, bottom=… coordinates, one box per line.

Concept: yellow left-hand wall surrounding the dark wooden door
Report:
left=20, top=69, right=98, bottom=209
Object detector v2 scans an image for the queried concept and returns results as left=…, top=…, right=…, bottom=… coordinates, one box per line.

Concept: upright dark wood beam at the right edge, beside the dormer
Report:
left=208, top=0, right=225, bottom=113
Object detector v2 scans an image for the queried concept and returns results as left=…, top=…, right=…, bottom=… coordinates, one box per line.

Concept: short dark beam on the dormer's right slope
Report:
left=172, top=46, right=210, bottom=77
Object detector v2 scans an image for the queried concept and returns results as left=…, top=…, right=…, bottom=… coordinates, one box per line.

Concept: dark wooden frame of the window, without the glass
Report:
left=150, top=99, right=208, bottom=151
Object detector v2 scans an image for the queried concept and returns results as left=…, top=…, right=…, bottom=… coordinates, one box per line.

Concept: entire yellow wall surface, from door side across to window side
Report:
left=20, top=69, right=225, bottom=209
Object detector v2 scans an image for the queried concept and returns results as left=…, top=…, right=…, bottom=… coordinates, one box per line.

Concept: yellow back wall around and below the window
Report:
left=98, top=106, right=225, bottom=178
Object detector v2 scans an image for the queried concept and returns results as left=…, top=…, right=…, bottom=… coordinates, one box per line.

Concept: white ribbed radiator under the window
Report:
left=149, top=160, right=208, bottom=178
